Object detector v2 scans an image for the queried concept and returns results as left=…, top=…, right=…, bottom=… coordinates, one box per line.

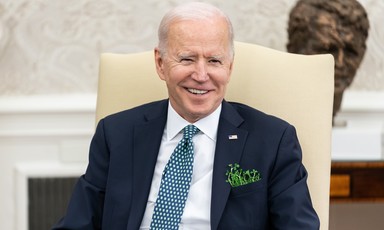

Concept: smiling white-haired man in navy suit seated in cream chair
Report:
left=54, top=3, right=319, bottom=230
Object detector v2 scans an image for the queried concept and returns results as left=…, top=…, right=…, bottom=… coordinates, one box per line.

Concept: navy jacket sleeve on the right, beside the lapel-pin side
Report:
left=268, top=126, right=320, bottom=230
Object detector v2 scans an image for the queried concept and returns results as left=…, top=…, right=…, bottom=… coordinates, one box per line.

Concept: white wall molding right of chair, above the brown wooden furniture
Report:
left=332, top=90, right=384, bottom=160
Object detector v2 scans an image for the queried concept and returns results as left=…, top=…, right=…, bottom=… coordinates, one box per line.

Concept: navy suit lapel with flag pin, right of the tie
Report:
left=211, top=101, right=248, bottom=229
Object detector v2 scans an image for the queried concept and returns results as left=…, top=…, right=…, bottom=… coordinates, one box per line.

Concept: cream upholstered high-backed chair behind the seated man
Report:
left=96, top=42, right=334, bottom=230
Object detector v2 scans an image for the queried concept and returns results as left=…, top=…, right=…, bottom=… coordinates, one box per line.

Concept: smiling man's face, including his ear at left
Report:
left=155, top=18, right=233, bottom=123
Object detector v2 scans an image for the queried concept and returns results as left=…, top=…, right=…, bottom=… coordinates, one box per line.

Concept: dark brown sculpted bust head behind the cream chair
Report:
left=287, top=0, right=369, bottom=116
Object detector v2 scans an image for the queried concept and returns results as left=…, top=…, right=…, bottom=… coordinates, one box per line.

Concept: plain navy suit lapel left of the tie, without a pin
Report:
left=127, top=100, right=168, bottom=229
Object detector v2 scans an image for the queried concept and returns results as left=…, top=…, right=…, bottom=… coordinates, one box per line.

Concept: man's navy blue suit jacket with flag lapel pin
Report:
left=53, top=100, right=319, bottom=230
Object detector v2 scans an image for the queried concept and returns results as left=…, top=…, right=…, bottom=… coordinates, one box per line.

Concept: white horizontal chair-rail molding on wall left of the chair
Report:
left=0, top=94, right=96, bottom=138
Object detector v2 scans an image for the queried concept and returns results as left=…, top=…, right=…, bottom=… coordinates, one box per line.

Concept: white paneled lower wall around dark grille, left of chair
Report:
left=0, top=95, right=96, bottom=230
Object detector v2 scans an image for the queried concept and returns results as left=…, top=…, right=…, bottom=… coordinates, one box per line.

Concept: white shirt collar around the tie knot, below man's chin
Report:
left=166, top=102, right=221, bottom=141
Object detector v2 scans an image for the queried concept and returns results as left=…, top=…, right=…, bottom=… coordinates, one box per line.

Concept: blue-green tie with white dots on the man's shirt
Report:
left=150, top=125, right=199, bottom=230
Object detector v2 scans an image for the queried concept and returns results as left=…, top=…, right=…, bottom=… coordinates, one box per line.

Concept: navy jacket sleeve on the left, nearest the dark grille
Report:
left=52, top=120, right=109, bottom=230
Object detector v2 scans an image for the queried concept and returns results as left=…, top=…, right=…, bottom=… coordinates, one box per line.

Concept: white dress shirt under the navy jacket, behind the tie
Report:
left=140, top=104, right=221, bottom=230
